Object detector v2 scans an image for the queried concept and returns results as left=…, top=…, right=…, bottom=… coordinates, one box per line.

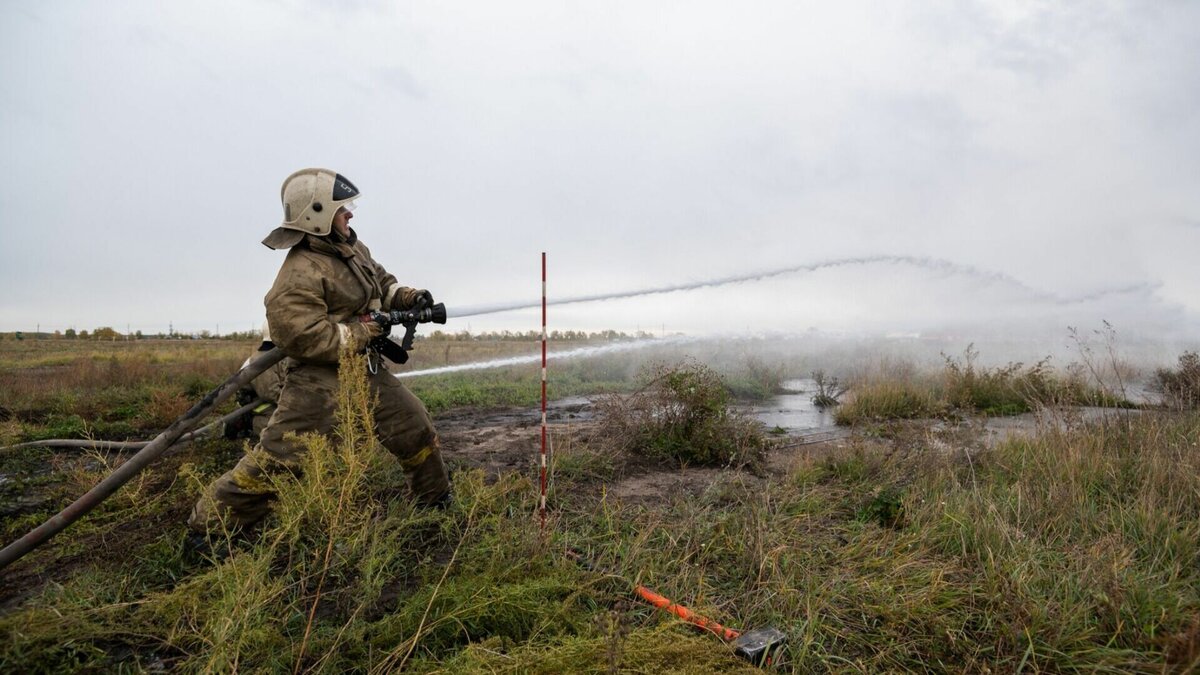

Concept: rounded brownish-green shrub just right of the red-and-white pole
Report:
left=599, top=362, right=766, bottom=467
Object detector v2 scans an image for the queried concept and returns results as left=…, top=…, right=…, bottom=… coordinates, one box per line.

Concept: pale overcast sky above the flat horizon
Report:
left=0, top=0, right=1200, bottom=339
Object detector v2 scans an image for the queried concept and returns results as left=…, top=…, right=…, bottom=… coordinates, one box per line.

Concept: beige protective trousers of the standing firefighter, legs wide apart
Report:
left=187, top=362, right=450, bottom=532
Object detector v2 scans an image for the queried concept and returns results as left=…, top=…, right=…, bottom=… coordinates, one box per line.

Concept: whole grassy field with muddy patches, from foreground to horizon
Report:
left=0, top=340, right=1200, bottom=673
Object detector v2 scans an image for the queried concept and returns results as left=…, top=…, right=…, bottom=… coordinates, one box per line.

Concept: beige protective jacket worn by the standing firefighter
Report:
left=264, top=229, right=419, bottom=364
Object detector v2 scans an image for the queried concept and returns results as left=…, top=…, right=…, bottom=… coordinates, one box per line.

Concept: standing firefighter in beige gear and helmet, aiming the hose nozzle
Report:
left=188, top=168, right=450, bottom=533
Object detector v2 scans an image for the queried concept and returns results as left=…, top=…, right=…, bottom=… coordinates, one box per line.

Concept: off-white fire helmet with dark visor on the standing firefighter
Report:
left=263, top=168, right=361, bottom=249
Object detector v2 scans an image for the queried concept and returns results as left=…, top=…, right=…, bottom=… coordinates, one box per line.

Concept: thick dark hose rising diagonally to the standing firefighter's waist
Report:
left=0, top=347, right=283, bottom=569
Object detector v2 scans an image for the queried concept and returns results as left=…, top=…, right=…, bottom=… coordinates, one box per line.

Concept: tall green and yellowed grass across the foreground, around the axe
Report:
left=0, top=336, right=1200, bottom=673
